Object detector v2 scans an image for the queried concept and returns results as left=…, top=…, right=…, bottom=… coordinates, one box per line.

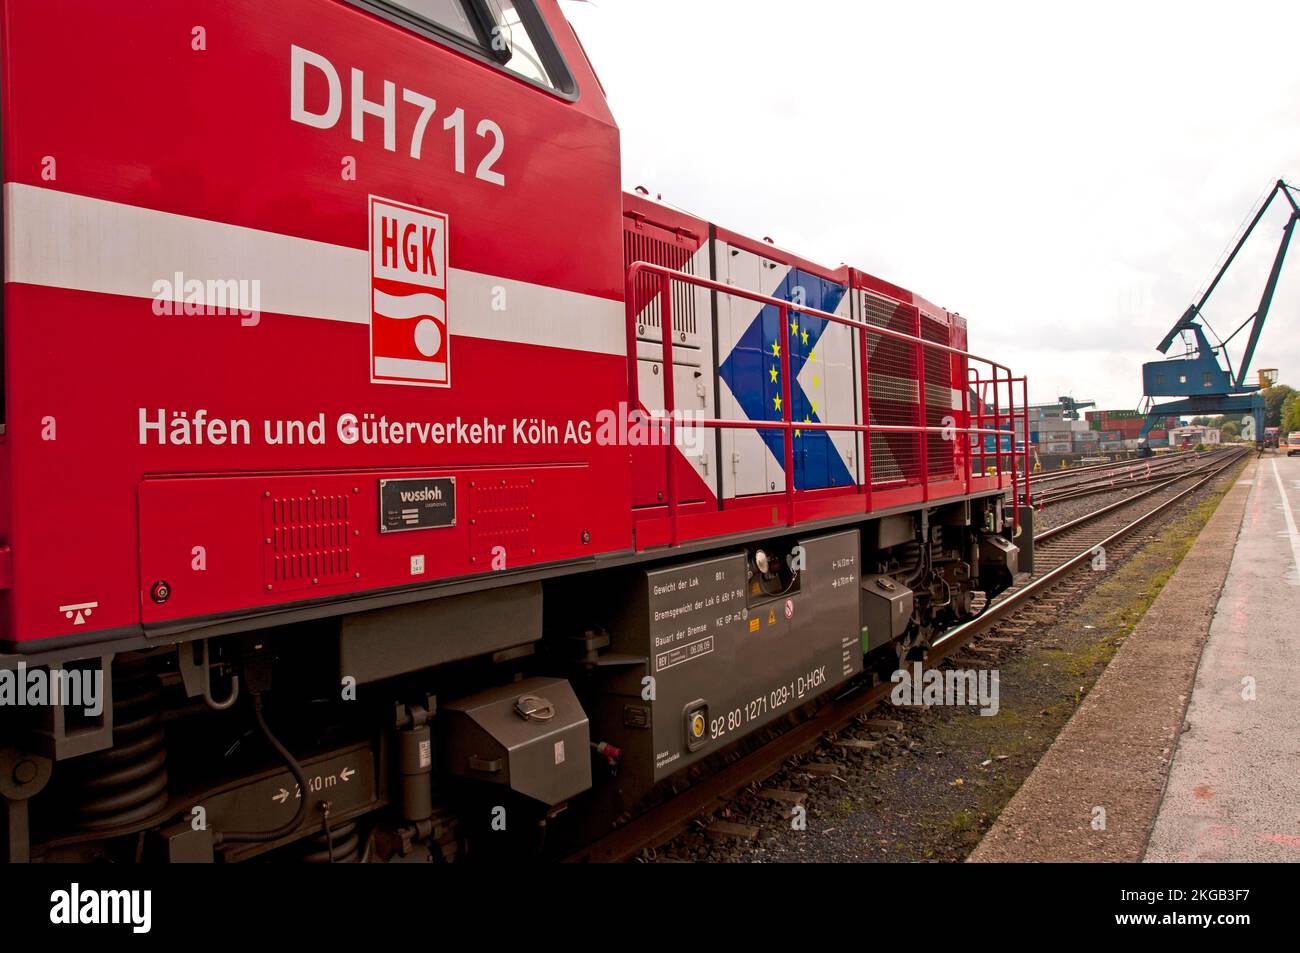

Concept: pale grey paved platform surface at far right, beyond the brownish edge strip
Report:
left=1145, top=456, right=1300, bottom=862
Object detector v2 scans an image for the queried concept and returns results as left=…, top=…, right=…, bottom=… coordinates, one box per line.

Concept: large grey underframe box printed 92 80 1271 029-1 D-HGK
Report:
left=593, top=529, right=862, bottom=792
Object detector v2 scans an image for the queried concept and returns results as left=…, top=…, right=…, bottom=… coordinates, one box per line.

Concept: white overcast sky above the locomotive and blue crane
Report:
left=562, top=0, right=1300, bottom=408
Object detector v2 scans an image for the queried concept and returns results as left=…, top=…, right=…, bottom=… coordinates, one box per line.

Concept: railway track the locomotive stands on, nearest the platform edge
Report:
left=566, top=449, right=1248, bottom=863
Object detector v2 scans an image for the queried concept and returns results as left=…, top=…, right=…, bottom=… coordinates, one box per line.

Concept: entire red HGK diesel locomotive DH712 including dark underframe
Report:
left=0, top=0, right=1030, bottom=862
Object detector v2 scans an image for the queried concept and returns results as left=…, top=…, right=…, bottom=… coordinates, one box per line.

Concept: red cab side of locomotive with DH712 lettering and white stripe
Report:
left=0, top=0, right=631, bottom=644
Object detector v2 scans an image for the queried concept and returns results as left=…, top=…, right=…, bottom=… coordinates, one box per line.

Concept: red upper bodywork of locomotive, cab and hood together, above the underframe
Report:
left=0, top=0, right=1024, bottom=651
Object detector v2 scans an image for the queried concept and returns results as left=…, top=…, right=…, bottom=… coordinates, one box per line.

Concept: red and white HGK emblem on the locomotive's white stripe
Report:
left=371, top=195, right=451, bottom=387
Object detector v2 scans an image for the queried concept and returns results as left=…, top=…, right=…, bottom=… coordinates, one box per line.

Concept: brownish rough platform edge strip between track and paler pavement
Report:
left=970, top=459, right=1253, bottom=862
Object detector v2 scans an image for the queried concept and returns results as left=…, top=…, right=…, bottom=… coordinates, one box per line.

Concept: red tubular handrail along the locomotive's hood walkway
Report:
left=625, top=261, right=1030, bottom=546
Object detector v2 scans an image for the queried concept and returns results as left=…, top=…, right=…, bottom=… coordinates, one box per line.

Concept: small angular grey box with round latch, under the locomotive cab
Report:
left=438, top=679, right=592, bottom=805
